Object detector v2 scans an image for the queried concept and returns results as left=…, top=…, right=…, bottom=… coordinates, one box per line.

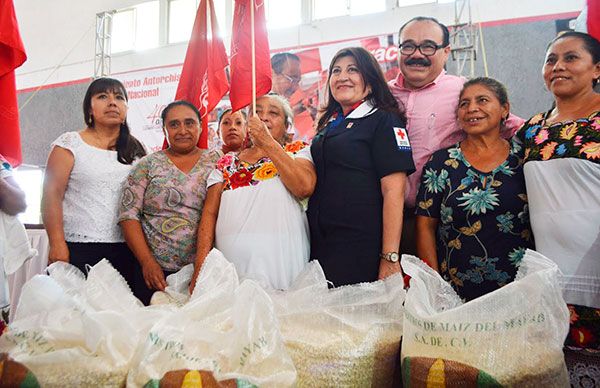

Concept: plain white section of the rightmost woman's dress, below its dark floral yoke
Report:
left=524, top=158, right=600, bottom=308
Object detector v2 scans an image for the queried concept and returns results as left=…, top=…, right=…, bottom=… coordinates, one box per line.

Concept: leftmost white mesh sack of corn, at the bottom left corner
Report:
left=0, top=260, right=169, bottom=387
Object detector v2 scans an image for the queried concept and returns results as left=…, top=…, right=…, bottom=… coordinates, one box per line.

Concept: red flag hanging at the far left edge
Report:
left=0, top=0, right=27, bottom=166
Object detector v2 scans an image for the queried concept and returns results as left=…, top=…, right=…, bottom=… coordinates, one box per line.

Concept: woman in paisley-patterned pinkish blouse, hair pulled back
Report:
left=119, top=101, right=219, bottom=304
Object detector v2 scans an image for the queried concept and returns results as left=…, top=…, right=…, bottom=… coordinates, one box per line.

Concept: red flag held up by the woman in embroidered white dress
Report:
left=229, top=0, right=271, bottom=111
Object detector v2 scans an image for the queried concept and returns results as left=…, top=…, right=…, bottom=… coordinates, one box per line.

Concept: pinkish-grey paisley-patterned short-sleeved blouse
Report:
left=119, top=150, right=219, bottom=271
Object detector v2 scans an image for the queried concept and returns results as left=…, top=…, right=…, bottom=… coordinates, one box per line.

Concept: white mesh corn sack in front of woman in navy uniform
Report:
left=271, top=261, right=405, bottom=387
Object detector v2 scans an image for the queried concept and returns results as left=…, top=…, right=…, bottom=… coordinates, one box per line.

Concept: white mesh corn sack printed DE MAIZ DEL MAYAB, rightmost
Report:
left=401, top=250, right=569, bottom=388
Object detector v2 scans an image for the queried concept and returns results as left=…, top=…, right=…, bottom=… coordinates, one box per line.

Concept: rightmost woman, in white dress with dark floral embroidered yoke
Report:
left=515, top=31, right=600, bottom=352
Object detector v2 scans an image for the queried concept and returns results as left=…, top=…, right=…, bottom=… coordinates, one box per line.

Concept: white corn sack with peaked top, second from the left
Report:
left=127, top=249, right=296, bottom=388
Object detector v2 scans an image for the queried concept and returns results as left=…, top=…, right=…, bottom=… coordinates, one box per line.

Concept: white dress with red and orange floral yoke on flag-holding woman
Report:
left=207, top=142, right=310, bottom=289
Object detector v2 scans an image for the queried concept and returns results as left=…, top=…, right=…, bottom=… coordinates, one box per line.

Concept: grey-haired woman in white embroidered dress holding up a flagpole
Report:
left=190, top=95, right=316, bottom=291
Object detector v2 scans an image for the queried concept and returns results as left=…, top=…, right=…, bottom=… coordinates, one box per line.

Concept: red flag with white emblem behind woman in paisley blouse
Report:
left=173, top=0, right=229, bottom=148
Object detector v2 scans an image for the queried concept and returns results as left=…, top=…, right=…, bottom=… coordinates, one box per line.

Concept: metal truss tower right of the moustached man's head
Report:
left=450, top=0, right=479, bottom=78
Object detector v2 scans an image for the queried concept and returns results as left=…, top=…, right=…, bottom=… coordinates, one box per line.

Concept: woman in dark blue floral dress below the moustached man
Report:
left=416, top=78, right=533, bottom=301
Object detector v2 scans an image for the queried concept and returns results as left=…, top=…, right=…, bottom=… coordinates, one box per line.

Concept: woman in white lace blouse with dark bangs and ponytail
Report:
left=42, top=78, right=146, bottom=290
